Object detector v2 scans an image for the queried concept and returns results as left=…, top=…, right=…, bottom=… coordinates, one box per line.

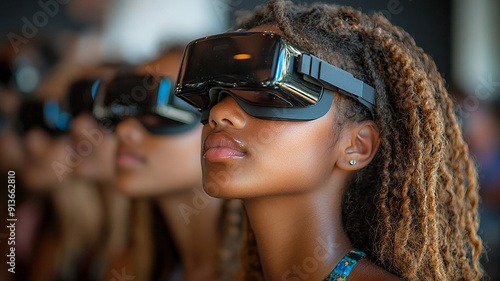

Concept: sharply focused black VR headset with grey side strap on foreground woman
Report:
left=176, top=31, right=375, bottom=124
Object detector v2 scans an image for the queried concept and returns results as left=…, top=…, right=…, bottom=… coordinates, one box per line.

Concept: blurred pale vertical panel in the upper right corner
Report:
left=453, top=0, right=500, bottom=97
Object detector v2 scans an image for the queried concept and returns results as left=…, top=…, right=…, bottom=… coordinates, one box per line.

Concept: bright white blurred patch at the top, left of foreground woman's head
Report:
left=102, top=0, right=228, bottom=63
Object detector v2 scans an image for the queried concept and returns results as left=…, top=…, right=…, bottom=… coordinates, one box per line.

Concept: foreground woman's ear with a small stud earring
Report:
left=337, top=120, right=380, bottom=171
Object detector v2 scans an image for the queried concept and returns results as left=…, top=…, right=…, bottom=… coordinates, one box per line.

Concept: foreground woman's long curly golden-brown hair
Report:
left=233, top=0, right=482, bottom=281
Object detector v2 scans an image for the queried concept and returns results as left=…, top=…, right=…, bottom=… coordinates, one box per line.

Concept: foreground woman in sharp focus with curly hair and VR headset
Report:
left=176, top=0, right=482, bottom=280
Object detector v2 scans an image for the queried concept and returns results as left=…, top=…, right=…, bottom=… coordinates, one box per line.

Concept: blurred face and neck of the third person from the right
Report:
left=68, top=64, right=133, bottom=278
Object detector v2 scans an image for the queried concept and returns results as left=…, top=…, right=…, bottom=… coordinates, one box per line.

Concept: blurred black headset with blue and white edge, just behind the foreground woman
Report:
left=93, top=74, right=200, bottom=135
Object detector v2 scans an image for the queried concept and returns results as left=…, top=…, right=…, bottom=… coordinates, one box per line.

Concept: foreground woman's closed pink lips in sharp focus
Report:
left=203, top=132, right=246, bottom=162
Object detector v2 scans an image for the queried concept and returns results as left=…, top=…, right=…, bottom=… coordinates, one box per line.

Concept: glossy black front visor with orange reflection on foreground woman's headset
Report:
left=177, top=32, right=321, bottom=110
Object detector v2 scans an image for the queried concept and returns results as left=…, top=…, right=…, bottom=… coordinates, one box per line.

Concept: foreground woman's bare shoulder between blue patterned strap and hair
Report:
left=347, top=259, right=403, bottom=281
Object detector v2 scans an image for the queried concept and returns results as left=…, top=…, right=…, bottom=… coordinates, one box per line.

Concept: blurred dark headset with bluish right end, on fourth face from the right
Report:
left=17, top=100, right=72, bottom=137
